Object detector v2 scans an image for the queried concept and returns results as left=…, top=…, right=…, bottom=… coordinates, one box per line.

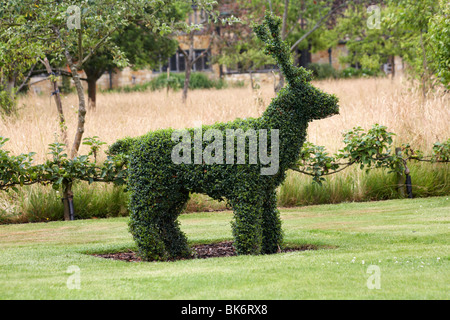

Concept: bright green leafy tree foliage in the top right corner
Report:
left=335, top=0, right=450, bottom=91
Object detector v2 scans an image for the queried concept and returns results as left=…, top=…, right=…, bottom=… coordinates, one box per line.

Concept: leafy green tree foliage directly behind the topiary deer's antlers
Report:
left=218, top=0, right=350, bottom=91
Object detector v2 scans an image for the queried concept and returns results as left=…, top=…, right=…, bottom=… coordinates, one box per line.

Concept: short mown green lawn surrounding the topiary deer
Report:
left=0, top=196, right=450, bottom=299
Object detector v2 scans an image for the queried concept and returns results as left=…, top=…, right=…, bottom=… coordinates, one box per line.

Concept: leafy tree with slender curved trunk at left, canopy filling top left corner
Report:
left=0, top=0, right=223, bottom=220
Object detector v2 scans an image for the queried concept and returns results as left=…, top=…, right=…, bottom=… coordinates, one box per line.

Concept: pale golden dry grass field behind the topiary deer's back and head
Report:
left=0, top=79, right=450, bottom=161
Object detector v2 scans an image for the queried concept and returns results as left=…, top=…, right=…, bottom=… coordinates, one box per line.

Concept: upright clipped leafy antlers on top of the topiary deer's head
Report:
left=253, top=12, right=311, bottom=86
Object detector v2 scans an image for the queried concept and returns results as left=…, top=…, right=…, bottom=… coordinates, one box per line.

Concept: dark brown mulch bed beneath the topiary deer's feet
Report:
left=93, top=241, right=318, bottom=262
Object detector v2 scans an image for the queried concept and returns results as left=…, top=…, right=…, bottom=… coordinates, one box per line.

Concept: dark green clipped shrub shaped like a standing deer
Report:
left=110, top=13, right=339, bottom=260
